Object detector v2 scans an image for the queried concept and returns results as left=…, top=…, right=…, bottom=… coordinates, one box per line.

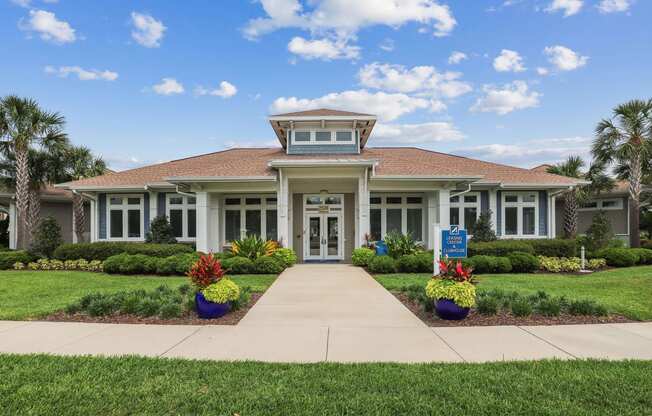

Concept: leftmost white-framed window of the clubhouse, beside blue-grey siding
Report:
left=107, top=195, right=144, bottom=240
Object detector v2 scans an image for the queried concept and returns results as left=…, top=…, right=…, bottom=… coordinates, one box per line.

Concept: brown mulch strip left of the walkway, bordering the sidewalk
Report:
left=43, top=293, right=263, bottom=325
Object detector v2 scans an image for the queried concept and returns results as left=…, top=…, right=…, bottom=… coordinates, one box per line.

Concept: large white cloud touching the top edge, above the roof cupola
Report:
left=243, top=0, right=457, bottom=39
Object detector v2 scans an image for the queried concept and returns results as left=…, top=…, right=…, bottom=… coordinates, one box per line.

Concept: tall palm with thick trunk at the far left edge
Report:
left=0, top=95, right=66, bottom=248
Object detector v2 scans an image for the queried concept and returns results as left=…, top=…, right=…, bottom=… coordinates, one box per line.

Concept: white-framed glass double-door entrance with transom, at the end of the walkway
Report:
left=303, top=194, right=344, bottom=260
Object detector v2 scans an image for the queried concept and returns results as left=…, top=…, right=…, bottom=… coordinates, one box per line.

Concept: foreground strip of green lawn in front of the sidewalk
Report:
left=0, top=355, right=652, bottom=416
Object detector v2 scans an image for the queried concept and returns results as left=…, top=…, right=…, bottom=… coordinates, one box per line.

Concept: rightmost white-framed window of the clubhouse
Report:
left=503, top=192, right=539, bottom=237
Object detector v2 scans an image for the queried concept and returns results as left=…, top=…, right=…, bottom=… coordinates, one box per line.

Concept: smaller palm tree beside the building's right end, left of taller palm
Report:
left=547, top=155, right=614, bottom=238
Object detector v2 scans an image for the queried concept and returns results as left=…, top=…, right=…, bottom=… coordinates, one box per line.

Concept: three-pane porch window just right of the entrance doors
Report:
left=369, top=194, right=425, bottom=241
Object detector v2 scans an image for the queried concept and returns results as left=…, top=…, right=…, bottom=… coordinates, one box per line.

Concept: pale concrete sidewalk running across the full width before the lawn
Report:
left=0, top=321, right=652, bottom=363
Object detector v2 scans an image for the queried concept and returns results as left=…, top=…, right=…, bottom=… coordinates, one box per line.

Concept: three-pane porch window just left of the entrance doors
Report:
left=223, top=195, right=278, bottom=242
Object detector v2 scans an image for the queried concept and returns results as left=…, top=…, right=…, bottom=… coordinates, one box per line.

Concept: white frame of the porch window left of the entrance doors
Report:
left=220, top=194, right=278, bottom=245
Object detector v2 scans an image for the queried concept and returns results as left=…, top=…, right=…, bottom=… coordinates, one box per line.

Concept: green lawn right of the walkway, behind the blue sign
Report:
left=375, top=266, right=652, bottom=320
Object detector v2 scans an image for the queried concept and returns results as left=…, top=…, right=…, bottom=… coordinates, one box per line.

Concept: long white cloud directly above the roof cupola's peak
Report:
left=270, top=90, right=432, bottom=121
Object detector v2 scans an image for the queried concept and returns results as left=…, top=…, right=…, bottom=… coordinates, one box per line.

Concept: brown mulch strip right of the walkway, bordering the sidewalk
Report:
left=392, top=292, right=637, bottom=326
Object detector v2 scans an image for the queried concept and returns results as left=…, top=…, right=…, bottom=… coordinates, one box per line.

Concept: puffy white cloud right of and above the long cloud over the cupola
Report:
left=358, top=62, right=472, bottom=98
